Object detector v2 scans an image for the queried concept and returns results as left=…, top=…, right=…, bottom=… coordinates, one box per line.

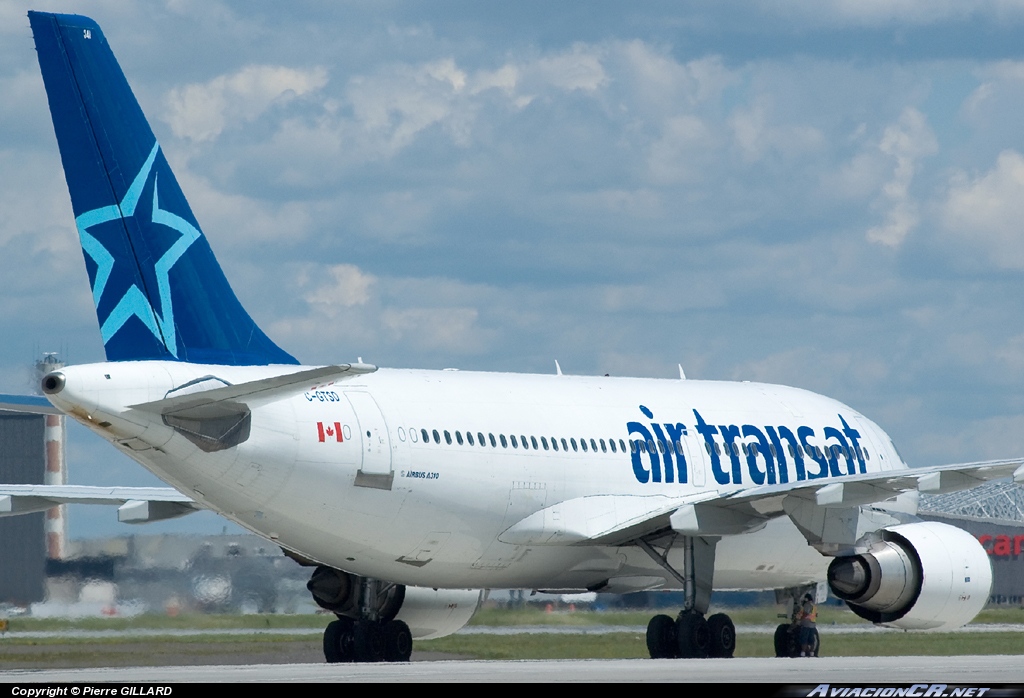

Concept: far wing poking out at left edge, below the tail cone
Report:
left=0, top=485, right=205, bottom=523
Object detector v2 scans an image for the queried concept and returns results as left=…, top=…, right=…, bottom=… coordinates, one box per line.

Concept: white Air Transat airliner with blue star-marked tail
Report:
left=0, top=11, right=1024, bottom=662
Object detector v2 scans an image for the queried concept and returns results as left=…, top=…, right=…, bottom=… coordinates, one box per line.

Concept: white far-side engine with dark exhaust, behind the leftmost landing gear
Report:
left=306, top=565, right=486, bottom=640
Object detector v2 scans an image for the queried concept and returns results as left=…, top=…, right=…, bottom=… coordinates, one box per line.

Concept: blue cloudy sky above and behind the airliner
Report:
left=0, top=0, right=1024, bottom=537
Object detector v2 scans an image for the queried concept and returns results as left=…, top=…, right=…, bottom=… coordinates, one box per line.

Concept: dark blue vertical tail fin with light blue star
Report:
left=29, top=12, right=297, bottom=365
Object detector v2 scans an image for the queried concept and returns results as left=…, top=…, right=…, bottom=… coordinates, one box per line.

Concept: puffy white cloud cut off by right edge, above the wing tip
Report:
left=942, top=150, right=1024, bottom=269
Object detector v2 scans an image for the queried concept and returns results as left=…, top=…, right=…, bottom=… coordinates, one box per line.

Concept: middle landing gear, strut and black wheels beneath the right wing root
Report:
left=637, top=536, right=736, bottom=659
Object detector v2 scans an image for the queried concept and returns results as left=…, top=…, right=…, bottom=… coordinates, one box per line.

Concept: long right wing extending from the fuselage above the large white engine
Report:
left=499, top=459, right=1024, bottom=546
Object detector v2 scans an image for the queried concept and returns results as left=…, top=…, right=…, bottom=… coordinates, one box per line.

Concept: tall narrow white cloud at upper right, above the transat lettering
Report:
left=867, top=106, right=938, bottom=248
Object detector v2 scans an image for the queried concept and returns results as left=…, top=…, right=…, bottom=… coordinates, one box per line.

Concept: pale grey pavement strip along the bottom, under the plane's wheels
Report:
left=0, top=655, right=1024, bottom=691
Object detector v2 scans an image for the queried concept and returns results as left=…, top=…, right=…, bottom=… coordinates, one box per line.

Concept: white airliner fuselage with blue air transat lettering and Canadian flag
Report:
left=51, top=361, right=905, bottom=590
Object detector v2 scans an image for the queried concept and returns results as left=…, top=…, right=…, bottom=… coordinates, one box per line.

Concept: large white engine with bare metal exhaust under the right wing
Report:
left=828, top=521, right=992, bottom=630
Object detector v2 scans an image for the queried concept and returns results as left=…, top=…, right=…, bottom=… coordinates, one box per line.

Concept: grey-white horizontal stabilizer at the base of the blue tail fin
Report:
left=131, top=363, right=377, bottom=416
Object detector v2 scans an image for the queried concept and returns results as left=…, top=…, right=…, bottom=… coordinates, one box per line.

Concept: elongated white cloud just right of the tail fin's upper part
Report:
left=165, top=66, right=328, bottom=141
